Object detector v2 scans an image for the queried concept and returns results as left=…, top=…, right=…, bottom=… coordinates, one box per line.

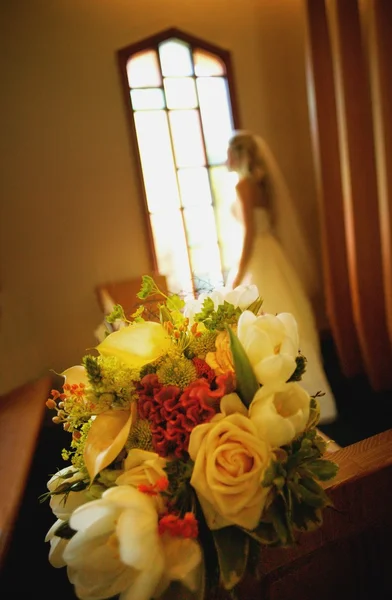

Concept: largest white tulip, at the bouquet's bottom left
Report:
left=63, top=485, right=201, bottom=600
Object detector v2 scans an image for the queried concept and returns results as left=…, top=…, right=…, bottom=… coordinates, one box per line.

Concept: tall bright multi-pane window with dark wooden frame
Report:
left=118, top=29, right=239, bottom=294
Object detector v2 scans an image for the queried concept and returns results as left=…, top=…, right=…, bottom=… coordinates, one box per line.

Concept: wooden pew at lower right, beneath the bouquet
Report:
left=210, top=430, right=392, bottom=600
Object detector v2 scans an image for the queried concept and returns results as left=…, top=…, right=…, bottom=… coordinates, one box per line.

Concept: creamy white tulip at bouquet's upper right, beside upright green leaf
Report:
left=237, top=310, right=299, bottom=385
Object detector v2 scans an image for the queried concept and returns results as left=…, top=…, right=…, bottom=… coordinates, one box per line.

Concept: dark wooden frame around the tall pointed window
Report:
left=117, top=27, right=240, bottom=292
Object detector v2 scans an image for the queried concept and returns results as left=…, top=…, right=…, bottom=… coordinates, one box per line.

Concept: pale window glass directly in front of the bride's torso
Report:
left=210, top=167, right=243, bottom=273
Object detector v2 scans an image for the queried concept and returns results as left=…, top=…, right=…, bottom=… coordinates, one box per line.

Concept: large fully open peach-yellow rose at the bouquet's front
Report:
left=189, top=410, right=273, bottom=529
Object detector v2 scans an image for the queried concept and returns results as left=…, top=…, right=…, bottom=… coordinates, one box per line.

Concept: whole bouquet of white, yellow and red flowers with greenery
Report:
left=44, top=276, right=337, bottom=600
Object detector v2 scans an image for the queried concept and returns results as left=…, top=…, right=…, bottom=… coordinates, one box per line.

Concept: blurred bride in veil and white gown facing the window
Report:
left=226, top=131, right=337, bottom=424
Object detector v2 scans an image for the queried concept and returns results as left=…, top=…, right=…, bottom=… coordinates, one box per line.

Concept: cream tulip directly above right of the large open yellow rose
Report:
left=249, top=383, right=310, bottom=448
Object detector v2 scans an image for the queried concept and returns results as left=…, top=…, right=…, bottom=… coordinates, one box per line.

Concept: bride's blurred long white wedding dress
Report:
left=227, top=201, right=337, bottom=424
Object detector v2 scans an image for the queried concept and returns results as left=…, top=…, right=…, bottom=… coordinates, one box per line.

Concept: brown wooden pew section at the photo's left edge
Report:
left=0, top=375, right=54, bottom=568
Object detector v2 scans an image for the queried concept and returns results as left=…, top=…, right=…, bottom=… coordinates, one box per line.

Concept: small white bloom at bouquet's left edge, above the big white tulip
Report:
left=47, top=467, right=89, bottom=521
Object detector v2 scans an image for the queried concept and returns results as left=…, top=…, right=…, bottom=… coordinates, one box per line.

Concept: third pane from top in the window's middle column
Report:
left=169, top=110, right=206, bottom=167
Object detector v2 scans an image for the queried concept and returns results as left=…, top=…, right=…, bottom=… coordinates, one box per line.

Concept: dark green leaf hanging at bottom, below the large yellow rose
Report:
left=212, top=527, right=249, bottom=590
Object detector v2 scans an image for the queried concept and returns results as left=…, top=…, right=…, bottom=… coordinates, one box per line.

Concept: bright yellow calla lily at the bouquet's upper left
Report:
left=97, top=321, right=170, bottom=369
